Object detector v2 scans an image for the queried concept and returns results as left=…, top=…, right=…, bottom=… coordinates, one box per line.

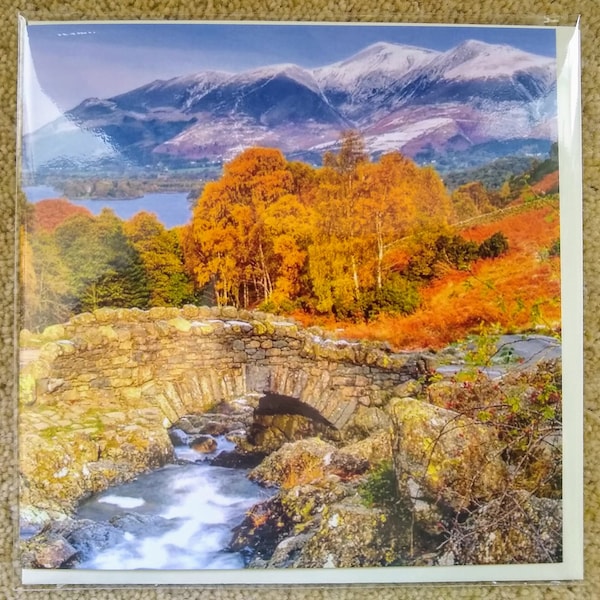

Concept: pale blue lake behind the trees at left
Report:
left=23, top=185, right=192, bottom=229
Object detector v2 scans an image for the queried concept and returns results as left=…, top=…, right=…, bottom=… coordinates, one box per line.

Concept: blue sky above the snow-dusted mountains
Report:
left=23, top=22, right=555, bottom=128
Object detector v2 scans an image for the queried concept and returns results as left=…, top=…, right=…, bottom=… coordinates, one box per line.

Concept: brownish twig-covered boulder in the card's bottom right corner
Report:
left=439, top=490, right=562, bottom=565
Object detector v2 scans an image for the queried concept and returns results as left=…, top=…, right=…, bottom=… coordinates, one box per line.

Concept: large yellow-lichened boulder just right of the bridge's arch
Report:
left=390, top=398, right=507, bottom=512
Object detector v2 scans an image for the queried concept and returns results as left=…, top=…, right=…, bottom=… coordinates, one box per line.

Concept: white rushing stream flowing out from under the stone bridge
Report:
left=76, top=436, right=273, bottom=569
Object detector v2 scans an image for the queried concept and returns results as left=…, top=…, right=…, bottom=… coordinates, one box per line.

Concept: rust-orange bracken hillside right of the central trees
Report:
left=330, top=199, right=560, bottom=349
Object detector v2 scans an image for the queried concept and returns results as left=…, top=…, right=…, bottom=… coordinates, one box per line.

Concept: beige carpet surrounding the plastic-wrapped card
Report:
left=0, top=0, right=600, bottom=600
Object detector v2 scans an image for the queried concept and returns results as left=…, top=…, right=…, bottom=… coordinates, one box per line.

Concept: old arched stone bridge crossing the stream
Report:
left=20, top=306, right=428, bottom=429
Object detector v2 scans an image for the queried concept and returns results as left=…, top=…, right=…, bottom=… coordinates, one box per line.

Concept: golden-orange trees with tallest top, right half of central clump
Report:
left=309, top=133, right=452, bottom=316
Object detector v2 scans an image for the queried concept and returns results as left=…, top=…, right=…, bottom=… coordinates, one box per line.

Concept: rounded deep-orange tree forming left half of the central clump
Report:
left=186, top=148, right=294, bottom=306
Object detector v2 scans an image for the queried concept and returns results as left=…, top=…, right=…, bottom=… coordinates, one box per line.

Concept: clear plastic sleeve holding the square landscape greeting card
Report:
left=14, top=12, right=584, bottom=593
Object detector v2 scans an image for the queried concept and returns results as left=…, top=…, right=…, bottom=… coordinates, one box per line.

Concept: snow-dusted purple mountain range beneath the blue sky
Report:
left=23, top=40, right=557, bottom=169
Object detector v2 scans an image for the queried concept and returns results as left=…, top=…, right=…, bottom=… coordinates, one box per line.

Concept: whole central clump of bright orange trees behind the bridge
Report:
left=183, top=136, right=452, bottom=316
